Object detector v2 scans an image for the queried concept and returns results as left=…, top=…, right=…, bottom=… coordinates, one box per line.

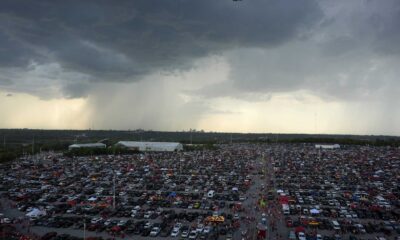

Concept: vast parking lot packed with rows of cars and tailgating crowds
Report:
left=0, top=144, right=400, bottom=240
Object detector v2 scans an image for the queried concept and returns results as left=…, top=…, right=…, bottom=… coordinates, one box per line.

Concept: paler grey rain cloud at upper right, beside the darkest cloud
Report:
left=195, top=1, right=400, bottom=101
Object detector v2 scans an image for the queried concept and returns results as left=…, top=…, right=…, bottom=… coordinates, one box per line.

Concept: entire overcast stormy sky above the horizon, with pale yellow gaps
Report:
left=0, top=0, right=400, bottom=135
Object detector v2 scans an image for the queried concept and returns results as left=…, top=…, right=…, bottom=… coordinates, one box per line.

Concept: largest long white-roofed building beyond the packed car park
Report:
left=116, top=141, right=183, bottom=152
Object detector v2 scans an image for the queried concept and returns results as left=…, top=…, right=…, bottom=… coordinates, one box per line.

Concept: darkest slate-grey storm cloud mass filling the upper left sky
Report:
left=0, top=0, right=322, bottom=96
